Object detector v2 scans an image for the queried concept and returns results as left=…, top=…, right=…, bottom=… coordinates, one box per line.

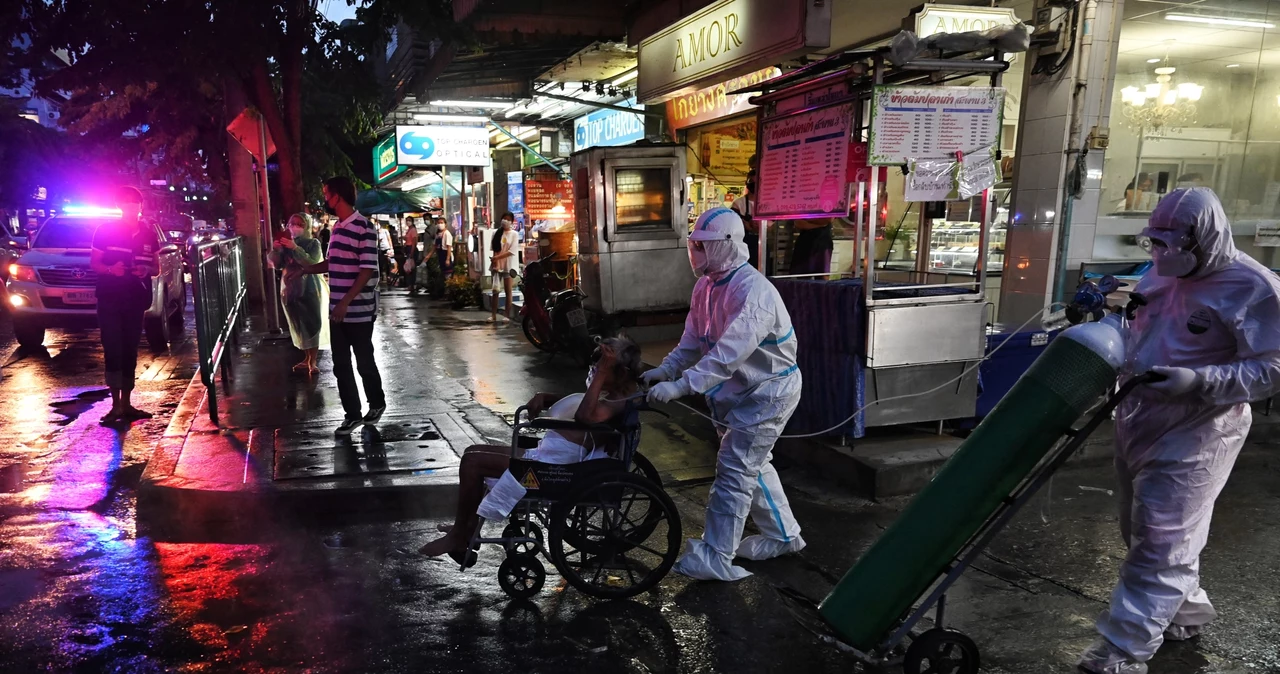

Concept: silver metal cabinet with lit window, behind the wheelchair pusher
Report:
left=571, top=145, right=695, bottom=340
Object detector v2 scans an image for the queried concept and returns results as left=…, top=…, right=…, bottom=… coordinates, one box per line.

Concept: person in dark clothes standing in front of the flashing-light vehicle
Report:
left=90, top=187, right=160, bottom=423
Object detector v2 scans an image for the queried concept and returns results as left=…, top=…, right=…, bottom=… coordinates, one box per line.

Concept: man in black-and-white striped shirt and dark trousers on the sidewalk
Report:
left=307, top=176, right=387, bottom=435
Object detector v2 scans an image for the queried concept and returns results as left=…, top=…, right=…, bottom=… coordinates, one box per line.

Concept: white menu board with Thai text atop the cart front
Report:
left=870, top=86, right=1005, bottom=165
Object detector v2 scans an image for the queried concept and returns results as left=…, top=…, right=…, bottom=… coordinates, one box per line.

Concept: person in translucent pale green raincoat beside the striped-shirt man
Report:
left=271, top=214, right=329, bottom=375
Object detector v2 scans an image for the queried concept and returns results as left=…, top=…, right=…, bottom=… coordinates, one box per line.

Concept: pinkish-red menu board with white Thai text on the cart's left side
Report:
left=755, top=104, right=854, bottom=219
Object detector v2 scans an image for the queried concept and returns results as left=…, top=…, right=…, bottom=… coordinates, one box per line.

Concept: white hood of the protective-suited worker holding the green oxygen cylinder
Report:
left=1148, top=187, right=1239, bottom=279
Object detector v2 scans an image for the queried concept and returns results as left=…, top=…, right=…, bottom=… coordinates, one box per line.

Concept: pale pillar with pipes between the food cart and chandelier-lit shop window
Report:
left=1000, top=0, right=1124, bottom=327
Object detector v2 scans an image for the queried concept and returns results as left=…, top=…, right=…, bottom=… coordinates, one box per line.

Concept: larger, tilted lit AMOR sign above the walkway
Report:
left=636, top=0, right=831, bottom=102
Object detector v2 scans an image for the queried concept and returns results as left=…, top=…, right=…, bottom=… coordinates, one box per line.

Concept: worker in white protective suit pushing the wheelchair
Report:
left=644, top=208, right=805, bottom=581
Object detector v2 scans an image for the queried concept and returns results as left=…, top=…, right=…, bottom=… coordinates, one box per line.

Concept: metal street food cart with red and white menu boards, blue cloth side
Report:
left=751, top=47, right=1007, bottom=437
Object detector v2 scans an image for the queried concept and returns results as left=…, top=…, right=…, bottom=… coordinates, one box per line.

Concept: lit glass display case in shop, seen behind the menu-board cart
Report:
left=929, top=183, right=1010, bottom=275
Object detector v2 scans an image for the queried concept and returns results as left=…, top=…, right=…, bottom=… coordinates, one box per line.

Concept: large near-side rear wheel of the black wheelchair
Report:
left=549, top=472, right=681, bottom=599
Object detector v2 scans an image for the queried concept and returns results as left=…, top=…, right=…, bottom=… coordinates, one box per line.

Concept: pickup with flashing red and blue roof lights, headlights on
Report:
left=6, top=208, right=187, bottom=350
